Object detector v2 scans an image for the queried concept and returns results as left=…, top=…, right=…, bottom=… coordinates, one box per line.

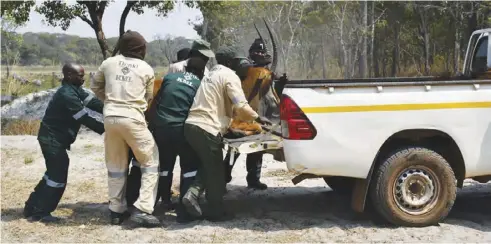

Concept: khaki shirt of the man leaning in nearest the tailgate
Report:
left=186, top=64, right=258, bottom=136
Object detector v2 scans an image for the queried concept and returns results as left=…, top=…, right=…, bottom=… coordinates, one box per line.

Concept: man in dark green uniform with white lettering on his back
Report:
left=146, top=58, right=206, bottom=222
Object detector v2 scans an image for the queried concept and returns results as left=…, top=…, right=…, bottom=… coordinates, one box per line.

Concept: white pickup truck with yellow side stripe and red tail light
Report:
left=280, top=29, right=491, bottom=226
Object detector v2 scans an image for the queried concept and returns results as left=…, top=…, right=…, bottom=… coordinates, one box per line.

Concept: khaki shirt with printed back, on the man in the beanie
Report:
left=90, top=55, right=155, bottom=123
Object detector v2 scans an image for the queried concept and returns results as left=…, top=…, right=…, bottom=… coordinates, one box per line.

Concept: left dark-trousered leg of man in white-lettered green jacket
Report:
left=154, top=128, right=177, bottom=209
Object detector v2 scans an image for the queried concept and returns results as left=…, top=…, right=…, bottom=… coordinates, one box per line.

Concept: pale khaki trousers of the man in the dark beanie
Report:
left=104, top=116, right=159, bottom=214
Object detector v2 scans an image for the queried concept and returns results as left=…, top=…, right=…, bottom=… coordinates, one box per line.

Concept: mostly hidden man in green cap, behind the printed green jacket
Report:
left=167, top=39, right=215, bottom=75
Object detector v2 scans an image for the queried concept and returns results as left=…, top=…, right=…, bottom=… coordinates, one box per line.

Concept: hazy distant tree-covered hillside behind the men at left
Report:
left=1, top=30, right=181, bottom=67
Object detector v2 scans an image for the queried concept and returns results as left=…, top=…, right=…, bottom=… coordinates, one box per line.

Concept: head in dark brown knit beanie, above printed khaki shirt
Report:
left=119, top=30, right=147, bottom=60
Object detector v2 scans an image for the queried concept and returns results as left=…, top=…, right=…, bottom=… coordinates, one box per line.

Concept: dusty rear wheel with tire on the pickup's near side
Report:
left=370, top=147, right=457, bottom=227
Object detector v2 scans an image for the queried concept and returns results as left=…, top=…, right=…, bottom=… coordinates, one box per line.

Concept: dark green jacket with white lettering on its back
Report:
left=154, top=72, right=201, bottom=128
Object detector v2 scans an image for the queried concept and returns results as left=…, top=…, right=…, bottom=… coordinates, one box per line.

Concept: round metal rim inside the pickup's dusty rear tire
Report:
left=394, top=166, right=440, bottom=215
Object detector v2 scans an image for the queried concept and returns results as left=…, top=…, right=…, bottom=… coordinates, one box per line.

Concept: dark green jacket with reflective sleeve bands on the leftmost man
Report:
left=38, top=83, right=104, bottom=149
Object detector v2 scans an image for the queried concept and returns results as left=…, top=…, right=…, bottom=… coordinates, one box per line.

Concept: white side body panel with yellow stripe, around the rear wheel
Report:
left=283, top=83, right=491, bottom=178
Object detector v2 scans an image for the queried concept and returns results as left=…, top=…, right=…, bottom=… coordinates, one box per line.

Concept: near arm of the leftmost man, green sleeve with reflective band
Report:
left=61, top=90, right=104, bottom=134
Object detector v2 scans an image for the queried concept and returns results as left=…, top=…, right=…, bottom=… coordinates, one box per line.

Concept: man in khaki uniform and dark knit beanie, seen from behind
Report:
left=91, top=31, right=160, bottom=227
